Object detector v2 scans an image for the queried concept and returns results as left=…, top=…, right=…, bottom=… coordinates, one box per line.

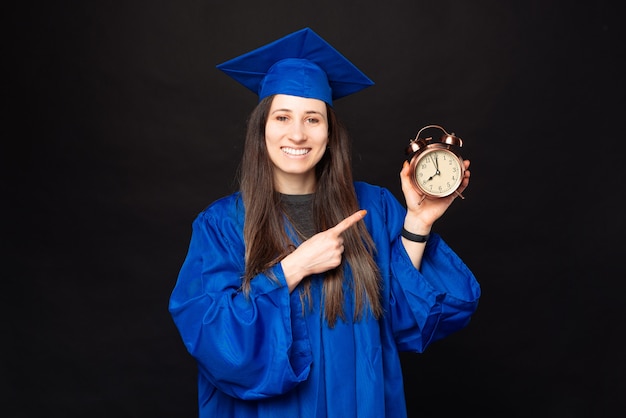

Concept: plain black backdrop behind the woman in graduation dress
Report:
left=6, top=0, right=626, bottom=417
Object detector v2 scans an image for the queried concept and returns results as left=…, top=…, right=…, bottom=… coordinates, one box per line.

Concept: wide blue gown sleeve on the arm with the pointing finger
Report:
left=169, top=199, right=312, bottom=400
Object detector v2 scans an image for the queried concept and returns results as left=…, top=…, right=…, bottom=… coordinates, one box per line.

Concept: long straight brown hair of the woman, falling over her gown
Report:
left=239, top=96, right=382, bottom=327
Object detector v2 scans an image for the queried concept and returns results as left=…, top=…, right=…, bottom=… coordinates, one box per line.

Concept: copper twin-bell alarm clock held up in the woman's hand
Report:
left=406, top=125, right=465, bottom=203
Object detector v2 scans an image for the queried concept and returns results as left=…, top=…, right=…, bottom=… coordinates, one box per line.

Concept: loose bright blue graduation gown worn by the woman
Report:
left=169, top=182, right=480, bottom=418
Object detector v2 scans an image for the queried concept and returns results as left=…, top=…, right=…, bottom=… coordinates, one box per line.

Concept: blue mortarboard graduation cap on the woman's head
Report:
left=217, top=28, right=374, bottom=105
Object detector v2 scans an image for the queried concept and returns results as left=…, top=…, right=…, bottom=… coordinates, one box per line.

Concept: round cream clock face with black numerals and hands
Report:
left=413, top=149, right=464, bottom=197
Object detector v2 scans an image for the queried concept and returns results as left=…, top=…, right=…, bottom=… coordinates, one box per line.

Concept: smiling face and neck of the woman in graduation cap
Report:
left=265, top=94, right=328, bottom=194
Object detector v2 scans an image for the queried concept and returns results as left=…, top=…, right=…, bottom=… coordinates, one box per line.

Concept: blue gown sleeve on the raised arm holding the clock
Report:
left=358, top=183, right=481, bottom=352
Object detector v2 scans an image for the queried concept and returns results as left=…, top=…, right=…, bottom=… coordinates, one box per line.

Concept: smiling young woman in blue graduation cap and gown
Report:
left=169, top=29, right=480, bottom=418
